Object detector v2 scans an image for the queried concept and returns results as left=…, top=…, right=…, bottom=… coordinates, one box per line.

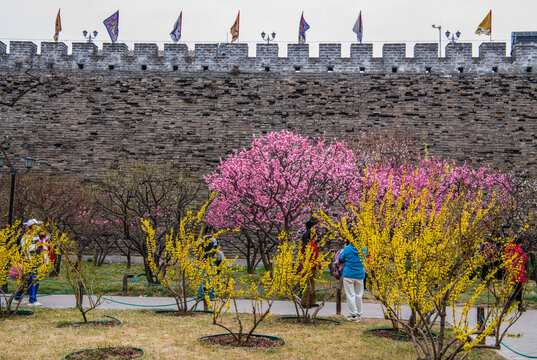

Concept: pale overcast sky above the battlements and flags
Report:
left=0, top=0, right=537, bottom=56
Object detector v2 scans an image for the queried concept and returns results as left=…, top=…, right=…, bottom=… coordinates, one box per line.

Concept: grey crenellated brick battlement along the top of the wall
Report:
left=0, top=41, right=537, bottom=74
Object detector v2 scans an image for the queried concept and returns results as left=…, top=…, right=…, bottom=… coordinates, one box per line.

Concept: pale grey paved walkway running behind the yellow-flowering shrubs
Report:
left=12, top=295, right=537, bottom=360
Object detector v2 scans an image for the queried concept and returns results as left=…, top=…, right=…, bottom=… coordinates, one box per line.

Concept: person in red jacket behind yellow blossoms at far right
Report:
left=505, top=243, right=528, bottom=311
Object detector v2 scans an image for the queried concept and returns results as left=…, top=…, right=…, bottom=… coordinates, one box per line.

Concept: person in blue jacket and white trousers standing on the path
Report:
left=339, top=244, right=367, bottom=322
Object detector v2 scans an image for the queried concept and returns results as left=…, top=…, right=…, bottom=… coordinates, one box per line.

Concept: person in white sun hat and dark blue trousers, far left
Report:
left=15, top=219, right=46, bottom=307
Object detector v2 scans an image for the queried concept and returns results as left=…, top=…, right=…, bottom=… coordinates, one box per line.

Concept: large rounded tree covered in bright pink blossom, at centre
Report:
left=205, top=131, right=359, bottom=271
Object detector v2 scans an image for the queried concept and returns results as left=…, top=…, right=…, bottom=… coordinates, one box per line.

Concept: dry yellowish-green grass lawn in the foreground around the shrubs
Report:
left=0, top=309, right=501, bottom=360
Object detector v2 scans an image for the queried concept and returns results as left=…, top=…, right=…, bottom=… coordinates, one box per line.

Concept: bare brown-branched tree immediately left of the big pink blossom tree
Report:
left=94, top=163, right=201, bottom=282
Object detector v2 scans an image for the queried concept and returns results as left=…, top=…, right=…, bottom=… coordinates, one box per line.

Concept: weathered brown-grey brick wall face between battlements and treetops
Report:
left=0, top=67, right=537, bottom=178
